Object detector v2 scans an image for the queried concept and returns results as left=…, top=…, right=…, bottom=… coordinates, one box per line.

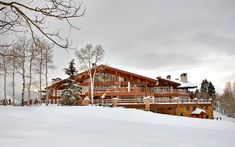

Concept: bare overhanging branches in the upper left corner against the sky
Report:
left=0, top=0, right=85, bottom=48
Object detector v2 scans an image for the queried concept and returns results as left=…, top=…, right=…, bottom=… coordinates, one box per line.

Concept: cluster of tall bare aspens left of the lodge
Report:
left=0, top=37, right=53, bottom=105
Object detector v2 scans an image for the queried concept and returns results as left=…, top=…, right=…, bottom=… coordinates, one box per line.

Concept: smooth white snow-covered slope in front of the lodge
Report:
left=0, top=106, right=235, bottom=147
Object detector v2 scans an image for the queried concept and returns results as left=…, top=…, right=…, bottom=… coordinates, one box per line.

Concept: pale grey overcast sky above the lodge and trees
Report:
left=1, top=0, right=235, bottom=95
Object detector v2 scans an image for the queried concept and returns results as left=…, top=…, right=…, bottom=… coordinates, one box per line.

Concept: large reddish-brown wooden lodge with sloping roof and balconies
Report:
left=47, top=65, right=213, bottom=118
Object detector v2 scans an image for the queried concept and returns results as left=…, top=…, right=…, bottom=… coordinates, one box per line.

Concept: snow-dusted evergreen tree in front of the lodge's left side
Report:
left=60, top=59, right=82, bottom=105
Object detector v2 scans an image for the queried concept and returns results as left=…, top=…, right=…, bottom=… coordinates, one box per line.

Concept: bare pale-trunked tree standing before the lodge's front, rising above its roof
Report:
left=75, top=44, right=105, bottom=105
